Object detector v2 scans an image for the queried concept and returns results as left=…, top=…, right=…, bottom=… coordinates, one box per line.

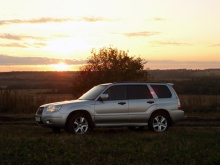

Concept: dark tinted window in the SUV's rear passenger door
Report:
left=128, top=85, right=152, bottom=100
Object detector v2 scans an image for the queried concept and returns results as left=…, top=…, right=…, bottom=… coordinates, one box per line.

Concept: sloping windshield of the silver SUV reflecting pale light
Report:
left=79, top=85, right=108, bottom=100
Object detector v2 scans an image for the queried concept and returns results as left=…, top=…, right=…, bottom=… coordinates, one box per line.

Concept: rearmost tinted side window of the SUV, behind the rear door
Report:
left=151, top=85, right=172, bottom=98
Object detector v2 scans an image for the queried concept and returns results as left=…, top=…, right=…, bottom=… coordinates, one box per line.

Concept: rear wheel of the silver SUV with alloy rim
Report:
left=148, top=112, right=170, bottom=132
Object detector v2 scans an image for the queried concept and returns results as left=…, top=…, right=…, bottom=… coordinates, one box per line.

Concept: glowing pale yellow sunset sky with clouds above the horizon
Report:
left=0, top=0, right=220, bottom=72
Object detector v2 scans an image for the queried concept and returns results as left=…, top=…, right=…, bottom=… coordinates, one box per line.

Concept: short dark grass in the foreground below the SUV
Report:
left=0, top=124, right=220, bottom=165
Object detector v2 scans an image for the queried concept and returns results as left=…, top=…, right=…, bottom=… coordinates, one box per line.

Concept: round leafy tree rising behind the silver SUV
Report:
left=73, top=46, right=148, bottom=94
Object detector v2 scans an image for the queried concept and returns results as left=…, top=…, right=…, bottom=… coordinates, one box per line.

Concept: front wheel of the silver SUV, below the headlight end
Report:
left=67, top=113, right=92, bottom=134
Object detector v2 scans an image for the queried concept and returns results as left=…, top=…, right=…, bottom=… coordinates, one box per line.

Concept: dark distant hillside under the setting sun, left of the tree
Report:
left=0, top=72, right=76, bottom=91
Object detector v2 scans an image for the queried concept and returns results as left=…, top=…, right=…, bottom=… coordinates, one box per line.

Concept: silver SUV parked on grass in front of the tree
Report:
left=35, top=82, right=184, bottom=134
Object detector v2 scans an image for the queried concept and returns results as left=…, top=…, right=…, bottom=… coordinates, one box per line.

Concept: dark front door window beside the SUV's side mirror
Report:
left=104, top=85, right=127, bottom=100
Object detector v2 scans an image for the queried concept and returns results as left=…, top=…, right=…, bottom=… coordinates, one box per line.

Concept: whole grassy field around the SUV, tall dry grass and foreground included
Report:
left=0, top=89, right=220, bottom=165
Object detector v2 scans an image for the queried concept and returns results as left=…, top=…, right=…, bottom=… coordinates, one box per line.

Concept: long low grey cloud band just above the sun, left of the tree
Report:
left=0, top=55, right=86, bottom=65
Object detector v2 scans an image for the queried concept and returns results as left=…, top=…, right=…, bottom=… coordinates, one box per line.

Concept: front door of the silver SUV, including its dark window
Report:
left=95, top=85, right=128, bottom=125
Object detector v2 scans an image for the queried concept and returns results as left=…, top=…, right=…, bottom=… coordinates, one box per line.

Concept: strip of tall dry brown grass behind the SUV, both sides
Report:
left=0, top=89, right=220, bottom=114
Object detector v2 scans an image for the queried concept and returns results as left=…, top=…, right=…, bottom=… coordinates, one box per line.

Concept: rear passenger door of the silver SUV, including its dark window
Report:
left=128, top=84, right=156, bottom=123
